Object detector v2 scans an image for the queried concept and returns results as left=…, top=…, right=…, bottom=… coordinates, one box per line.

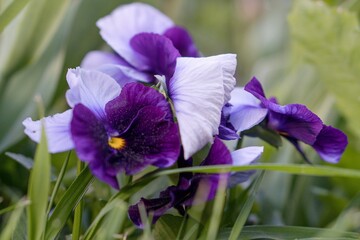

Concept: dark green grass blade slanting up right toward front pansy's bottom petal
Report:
left=45, top=167, right=94, bottom=239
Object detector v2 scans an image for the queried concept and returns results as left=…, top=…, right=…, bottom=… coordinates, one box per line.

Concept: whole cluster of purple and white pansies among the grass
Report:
left=23, top=3, right=347, bottom=227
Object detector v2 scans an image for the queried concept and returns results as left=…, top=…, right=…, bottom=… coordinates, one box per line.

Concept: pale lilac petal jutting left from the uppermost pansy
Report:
left=80, top=51, right=130, bottom=70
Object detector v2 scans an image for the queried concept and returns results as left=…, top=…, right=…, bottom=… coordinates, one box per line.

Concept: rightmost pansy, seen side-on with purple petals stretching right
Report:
left=230, top=77, right=347, bottom=163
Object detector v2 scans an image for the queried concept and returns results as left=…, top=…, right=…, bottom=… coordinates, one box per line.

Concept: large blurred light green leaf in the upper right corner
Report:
left=289, top=0, right=360, bottom=139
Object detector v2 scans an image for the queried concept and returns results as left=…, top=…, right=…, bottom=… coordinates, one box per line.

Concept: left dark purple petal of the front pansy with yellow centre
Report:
left=71, top=104, right=119, bottom=189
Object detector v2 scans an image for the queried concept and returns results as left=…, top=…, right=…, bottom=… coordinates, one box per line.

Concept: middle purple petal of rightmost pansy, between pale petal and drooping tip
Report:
left=268, top=103, right=323, bottom=145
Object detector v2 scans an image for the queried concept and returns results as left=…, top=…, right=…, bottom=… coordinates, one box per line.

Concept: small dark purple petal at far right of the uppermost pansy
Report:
left=164, top=26, right=200, bottom=57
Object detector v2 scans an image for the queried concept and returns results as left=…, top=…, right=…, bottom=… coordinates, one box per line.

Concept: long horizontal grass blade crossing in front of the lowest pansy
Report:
left=152, top=164, right=360, bottom=178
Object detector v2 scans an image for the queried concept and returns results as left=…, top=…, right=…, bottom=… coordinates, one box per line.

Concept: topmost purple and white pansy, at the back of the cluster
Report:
left=81, top=3, right=200, bottom=84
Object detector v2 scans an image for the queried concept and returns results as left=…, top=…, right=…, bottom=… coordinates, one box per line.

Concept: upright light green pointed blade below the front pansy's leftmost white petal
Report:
left=27, top=122, right=51, bottom=240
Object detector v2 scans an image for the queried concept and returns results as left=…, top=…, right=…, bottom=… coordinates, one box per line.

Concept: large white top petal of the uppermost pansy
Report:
left=96, top=3, right=174, bottom=70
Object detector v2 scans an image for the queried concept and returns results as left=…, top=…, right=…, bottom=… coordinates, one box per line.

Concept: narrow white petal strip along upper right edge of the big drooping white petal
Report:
left=204, top=53, right=236, bottom=104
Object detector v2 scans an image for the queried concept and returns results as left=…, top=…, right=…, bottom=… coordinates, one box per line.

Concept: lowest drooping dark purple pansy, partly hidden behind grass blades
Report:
left=128, top=138, right=263, bottom=227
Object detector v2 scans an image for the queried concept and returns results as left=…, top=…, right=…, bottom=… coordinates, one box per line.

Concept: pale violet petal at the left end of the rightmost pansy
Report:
left=230, top=105, right=268, bottom=132
